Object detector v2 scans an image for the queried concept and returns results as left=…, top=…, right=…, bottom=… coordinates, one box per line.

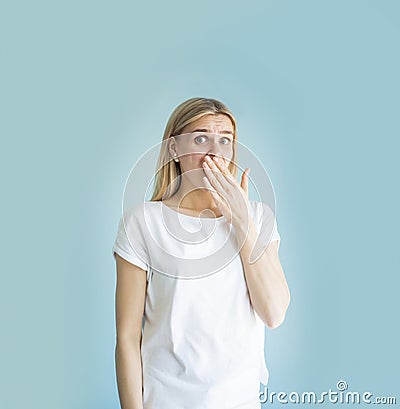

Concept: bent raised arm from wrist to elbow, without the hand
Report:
left=238, top=220, right=290, bottom=328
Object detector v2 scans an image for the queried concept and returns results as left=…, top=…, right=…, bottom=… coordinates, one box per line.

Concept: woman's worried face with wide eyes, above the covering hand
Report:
left=170, top=114, right=233, bottom=186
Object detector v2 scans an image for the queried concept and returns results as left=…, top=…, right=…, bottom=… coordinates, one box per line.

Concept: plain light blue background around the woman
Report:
left=0, top=0, right=400, bottom=409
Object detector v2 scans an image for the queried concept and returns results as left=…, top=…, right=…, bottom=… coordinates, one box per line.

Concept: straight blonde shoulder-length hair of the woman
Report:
left=150, top=98, right=237, bottom=201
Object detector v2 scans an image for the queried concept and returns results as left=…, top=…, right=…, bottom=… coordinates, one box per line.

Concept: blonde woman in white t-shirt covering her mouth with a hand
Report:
left=113, top=98, right=290, bottom=409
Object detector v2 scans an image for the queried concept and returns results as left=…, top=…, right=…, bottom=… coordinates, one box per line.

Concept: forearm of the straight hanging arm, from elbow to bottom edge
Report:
left=115, top=341, right=143, bottom=409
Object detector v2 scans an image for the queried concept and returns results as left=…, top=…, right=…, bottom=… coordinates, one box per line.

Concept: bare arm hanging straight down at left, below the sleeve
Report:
left=115, top=254, right=147, bottom=409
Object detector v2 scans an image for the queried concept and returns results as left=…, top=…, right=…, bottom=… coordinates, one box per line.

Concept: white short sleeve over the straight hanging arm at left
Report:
left=112, top=209, right=149, bottom=271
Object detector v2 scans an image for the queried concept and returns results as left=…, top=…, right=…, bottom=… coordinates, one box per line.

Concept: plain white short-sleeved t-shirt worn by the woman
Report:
left=113, top=201, right=280, bottom=409
